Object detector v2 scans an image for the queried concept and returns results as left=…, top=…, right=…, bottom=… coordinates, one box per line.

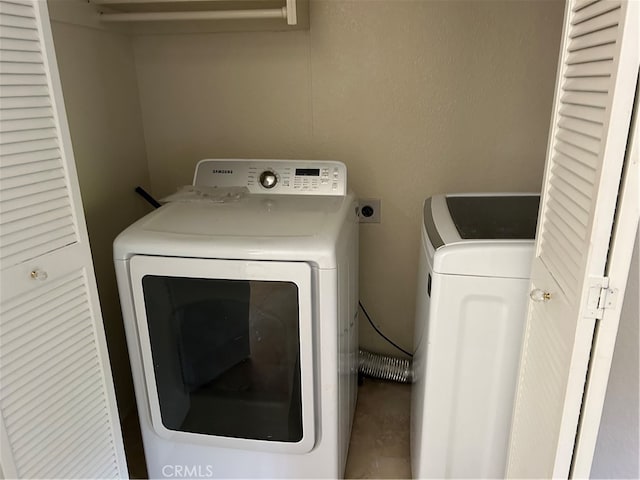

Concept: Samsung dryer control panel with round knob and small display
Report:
left=193, top=159, right=347, bottom=195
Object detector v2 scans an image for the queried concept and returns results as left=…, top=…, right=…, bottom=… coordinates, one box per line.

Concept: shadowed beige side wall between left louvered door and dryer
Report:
left=50, top=6, right=149, bottom=415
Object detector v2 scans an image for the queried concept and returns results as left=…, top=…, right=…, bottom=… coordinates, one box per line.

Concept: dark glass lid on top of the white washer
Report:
left=447, top=195, right=540, bottom=240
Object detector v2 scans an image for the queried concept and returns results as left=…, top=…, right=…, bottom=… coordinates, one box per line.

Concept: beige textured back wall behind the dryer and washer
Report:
left=134, top=0, right=563, bottom=353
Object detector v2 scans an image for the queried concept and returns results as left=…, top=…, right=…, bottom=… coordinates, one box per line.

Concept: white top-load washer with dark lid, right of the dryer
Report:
left=411, top=194, right=539, bottom=478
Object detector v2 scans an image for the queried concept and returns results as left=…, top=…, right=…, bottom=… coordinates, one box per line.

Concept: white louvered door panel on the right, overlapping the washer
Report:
left=507, top=0, right=639, bottom=478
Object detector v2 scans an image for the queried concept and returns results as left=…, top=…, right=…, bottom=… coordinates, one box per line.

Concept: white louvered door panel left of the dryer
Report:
left=0, top=0, right=128, bottom=478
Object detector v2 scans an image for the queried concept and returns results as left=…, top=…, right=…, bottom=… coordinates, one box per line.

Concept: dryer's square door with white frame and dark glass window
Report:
left=131, top=256, right=314, bottom=451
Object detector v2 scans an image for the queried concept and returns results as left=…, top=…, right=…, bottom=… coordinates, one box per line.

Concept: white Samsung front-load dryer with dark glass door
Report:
left=114, top=160, right=358, bottom=478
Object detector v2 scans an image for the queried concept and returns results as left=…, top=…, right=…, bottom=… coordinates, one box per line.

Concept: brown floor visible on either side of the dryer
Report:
left=123, top=378, right=411, bottom=479
